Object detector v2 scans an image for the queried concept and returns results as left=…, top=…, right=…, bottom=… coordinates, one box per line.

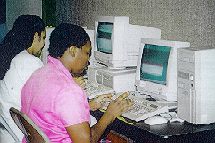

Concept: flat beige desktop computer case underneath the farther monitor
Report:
left=88, top=66, right=136, bottom=93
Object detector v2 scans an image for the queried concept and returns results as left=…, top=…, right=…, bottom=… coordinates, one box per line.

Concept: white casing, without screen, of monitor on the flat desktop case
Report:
left=94, top=16, right=161, bottom=69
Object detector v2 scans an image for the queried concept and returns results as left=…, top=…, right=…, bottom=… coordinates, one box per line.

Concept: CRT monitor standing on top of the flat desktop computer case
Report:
left=94, top=16, right=161, bottom=69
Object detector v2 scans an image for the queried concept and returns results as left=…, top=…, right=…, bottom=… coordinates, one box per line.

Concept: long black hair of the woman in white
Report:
left=0, top=15, right=45, bottom=80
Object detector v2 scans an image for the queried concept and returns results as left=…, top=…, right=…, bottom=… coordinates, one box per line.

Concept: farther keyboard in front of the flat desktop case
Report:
left=85, top=80, right=114, bottom=99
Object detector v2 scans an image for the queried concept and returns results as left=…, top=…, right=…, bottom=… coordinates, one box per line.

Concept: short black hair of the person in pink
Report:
left=48, top=23, right=90, bottom=58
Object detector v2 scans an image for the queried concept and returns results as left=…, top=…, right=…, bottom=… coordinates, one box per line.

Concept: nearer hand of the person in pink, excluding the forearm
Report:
left=105, top=92, right=133, bottom=121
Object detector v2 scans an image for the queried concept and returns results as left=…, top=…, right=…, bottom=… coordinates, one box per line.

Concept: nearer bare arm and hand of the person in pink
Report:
left=66, top=93, right=132, bottom=143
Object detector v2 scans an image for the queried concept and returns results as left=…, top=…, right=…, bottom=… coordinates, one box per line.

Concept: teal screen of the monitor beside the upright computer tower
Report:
left=140, top=44, right=171, bottom=85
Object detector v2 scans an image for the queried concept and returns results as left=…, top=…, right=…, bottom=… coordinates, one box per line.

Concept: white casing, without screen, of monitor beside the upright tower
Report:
left=135, top=38, right=190, bottom=101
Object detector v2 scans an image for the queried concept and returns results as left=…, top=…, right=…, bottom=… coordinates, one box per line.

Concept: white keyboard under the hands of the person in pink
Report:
left=103, top=92, right=169, bottom=122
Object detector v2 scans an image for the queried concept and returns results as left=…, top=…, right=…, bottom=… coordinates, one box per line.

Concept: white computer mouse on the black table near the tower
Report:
left=144, top=116, right=168, bottom=125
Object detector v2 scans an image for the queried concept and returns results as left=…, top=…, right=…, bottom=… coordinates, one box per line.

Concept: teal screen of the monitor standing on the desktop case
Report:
left=96, top=22, right=113, bottom=54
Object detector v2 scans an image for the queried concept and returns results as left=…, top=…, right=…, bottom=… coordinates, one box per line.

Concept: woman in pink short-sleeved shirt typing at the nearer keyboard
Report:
left=21, top=23, right=132, bottom=143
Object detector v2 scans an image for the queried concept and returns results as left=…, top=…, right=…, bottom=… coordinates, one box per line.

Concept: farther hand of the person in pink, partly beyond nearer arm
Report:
left=89, top=94, right=112, bottom=111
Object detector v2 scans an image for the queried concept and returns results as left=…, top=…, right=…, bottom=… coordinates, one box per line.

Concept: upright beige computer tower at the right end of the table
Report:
left=177, top=48, right=215, bottom=124
